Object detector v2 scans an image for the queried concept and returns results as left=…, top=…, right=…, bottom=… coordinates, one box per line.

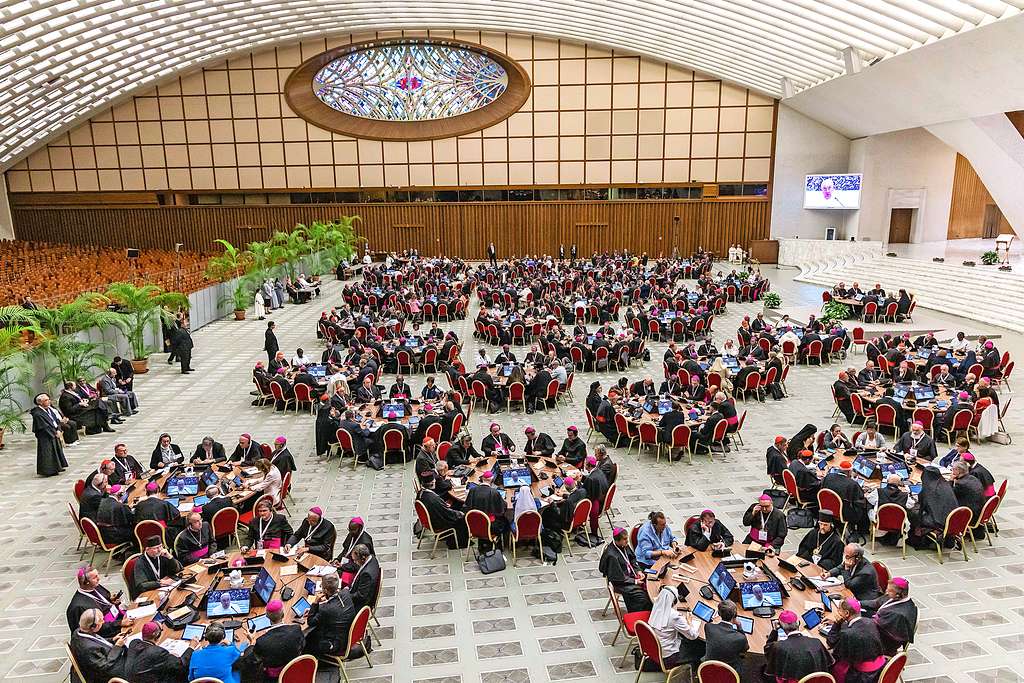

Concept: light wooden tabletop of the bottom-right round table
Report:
left=645, top=543, right=853, bottom=654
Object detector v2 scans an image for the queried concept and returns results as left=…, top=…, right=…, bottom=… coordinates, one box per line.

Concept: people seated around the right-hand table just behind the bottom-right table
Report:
left=765, top=423, right=996, bottom=548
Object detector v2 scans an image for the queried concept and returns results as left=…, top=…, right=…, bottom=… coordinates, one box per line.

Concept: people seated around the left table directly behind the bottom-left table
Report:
left=78, top=433, right=297, bottom=563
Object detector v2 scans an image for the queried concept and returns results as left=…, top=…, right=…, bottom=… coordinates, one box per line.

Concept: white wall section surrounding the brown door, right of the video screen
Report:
left=846, top=128, right=956, bottom=243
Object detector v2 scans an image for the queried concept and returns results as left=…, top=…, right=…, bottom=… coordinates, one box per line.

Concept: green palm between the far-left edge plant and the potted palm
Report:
left=24, top=295, right=127, bottom=383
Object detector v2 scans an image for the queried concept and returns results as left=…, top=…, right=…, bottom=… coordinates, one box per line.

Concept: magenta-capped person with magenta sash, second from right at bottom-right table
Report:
left=825, top=598, right=886, bottom=683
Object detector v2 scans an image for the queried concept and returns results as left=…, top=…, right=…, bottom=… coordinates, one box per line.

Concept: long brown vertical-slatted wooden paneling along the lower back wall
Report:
left=12, top=200, right=770, bottom=259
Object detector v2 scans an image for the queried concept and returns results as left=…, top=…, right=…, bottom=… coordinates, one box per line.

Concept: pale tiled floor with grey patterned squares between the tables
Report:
left=6, top=268, right=1024, bottom=683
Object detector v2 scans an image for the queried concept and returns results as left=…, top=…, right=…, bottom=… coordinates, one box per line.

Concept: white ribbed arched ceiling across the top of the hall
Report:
left=0, top=0, right=1024, bottom=168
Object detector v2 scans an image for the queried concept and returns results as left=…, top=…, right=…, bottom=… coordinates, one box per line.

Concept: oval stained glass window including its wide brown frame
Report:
left=285, top=38, right=530, bottom=140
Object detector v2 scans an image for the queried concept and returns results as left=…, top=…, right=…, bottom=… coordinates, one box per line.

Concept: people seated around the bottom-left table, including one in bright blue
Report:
left=67, top=516, right=382, bottom=683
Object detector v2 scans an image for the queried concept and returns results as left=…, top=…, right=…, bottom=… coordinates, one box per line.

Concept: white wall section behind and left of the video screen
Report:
left=771, top=104, right=850, bottom=240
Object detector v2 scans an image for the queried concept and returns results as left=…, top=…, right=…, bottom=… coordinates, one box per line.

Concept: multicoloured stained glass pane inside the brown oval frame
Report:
left=312, top=43, right=508, bottom=121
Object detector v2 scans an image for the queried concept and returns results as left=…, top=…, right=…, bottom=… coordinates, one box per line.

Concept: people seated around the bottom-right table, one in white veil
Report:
left=598, top=505, right=918, bottom=683
